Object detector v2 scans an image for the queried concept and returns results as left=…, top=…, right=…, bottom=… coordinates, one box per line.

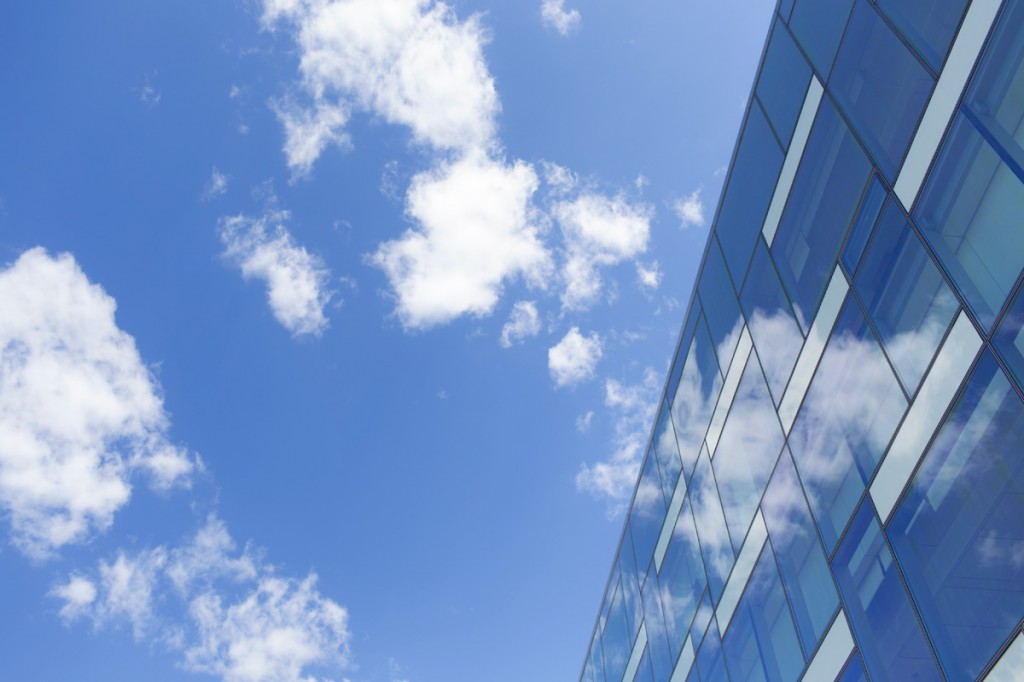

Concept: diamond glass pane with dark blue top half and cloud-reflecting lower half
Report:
left=740, top=240, right=803, bottom=404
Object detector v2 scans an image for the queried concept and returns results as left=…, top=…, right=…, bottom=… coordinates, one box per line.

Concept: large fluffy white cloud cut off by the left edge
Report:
left=0, top=249, right=195, bottom=557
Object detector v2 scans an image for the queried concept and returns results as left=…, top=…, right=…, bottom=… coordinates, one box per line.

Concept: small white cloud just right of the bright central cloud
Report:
left=552, top=194, right=651, bottom=310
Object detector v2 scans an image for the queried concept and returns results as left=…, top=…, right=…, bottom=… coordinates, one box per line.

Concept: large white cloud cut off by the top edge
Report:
left=263, top=0, right=500, bottom=164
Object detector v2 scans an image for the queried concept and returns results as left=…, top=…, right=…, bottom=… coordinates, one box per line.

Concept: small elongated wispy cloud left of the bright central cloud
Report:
left=219, top=206, right=332, bottom=336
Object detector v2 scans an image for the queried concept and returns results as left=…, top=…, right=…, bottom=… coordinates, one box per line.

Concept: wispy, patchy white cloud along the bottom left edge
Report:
left=50, top=516, right=350, bottom=682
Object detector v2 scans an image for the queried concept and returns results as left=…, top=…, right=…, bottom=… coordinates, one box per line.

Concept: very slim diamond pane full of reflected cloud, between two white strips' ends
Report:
left=689, top=450, right=735, bottom=603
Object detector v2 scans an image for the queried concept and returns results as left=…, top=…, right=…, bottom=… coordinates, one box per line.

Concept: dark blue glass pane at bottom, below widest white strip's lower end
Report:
left=833, top=500, right=942, bottom=682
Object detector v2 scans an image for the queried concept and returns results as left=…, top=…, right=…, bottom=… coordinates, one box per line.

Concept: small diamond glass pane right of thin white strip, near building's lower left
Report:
left=658, top=500, right=708, bottom=659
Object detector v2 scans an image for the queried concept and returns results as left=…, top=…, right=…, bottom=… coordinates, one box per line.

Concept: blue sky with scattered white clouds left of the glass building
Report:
left=0, top=0, right=772, bottom=682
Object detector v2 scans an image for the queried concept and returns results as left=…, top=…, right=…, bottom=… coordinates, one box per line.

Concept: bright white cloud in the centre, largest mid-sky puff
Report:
left=371, top=155, right=551, bottom=329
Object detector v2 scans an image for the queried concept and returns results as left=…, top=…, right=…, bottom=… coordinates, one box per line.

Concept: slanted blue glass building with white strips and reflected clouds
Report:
left=581, top=0, right=1024, bottom=682
